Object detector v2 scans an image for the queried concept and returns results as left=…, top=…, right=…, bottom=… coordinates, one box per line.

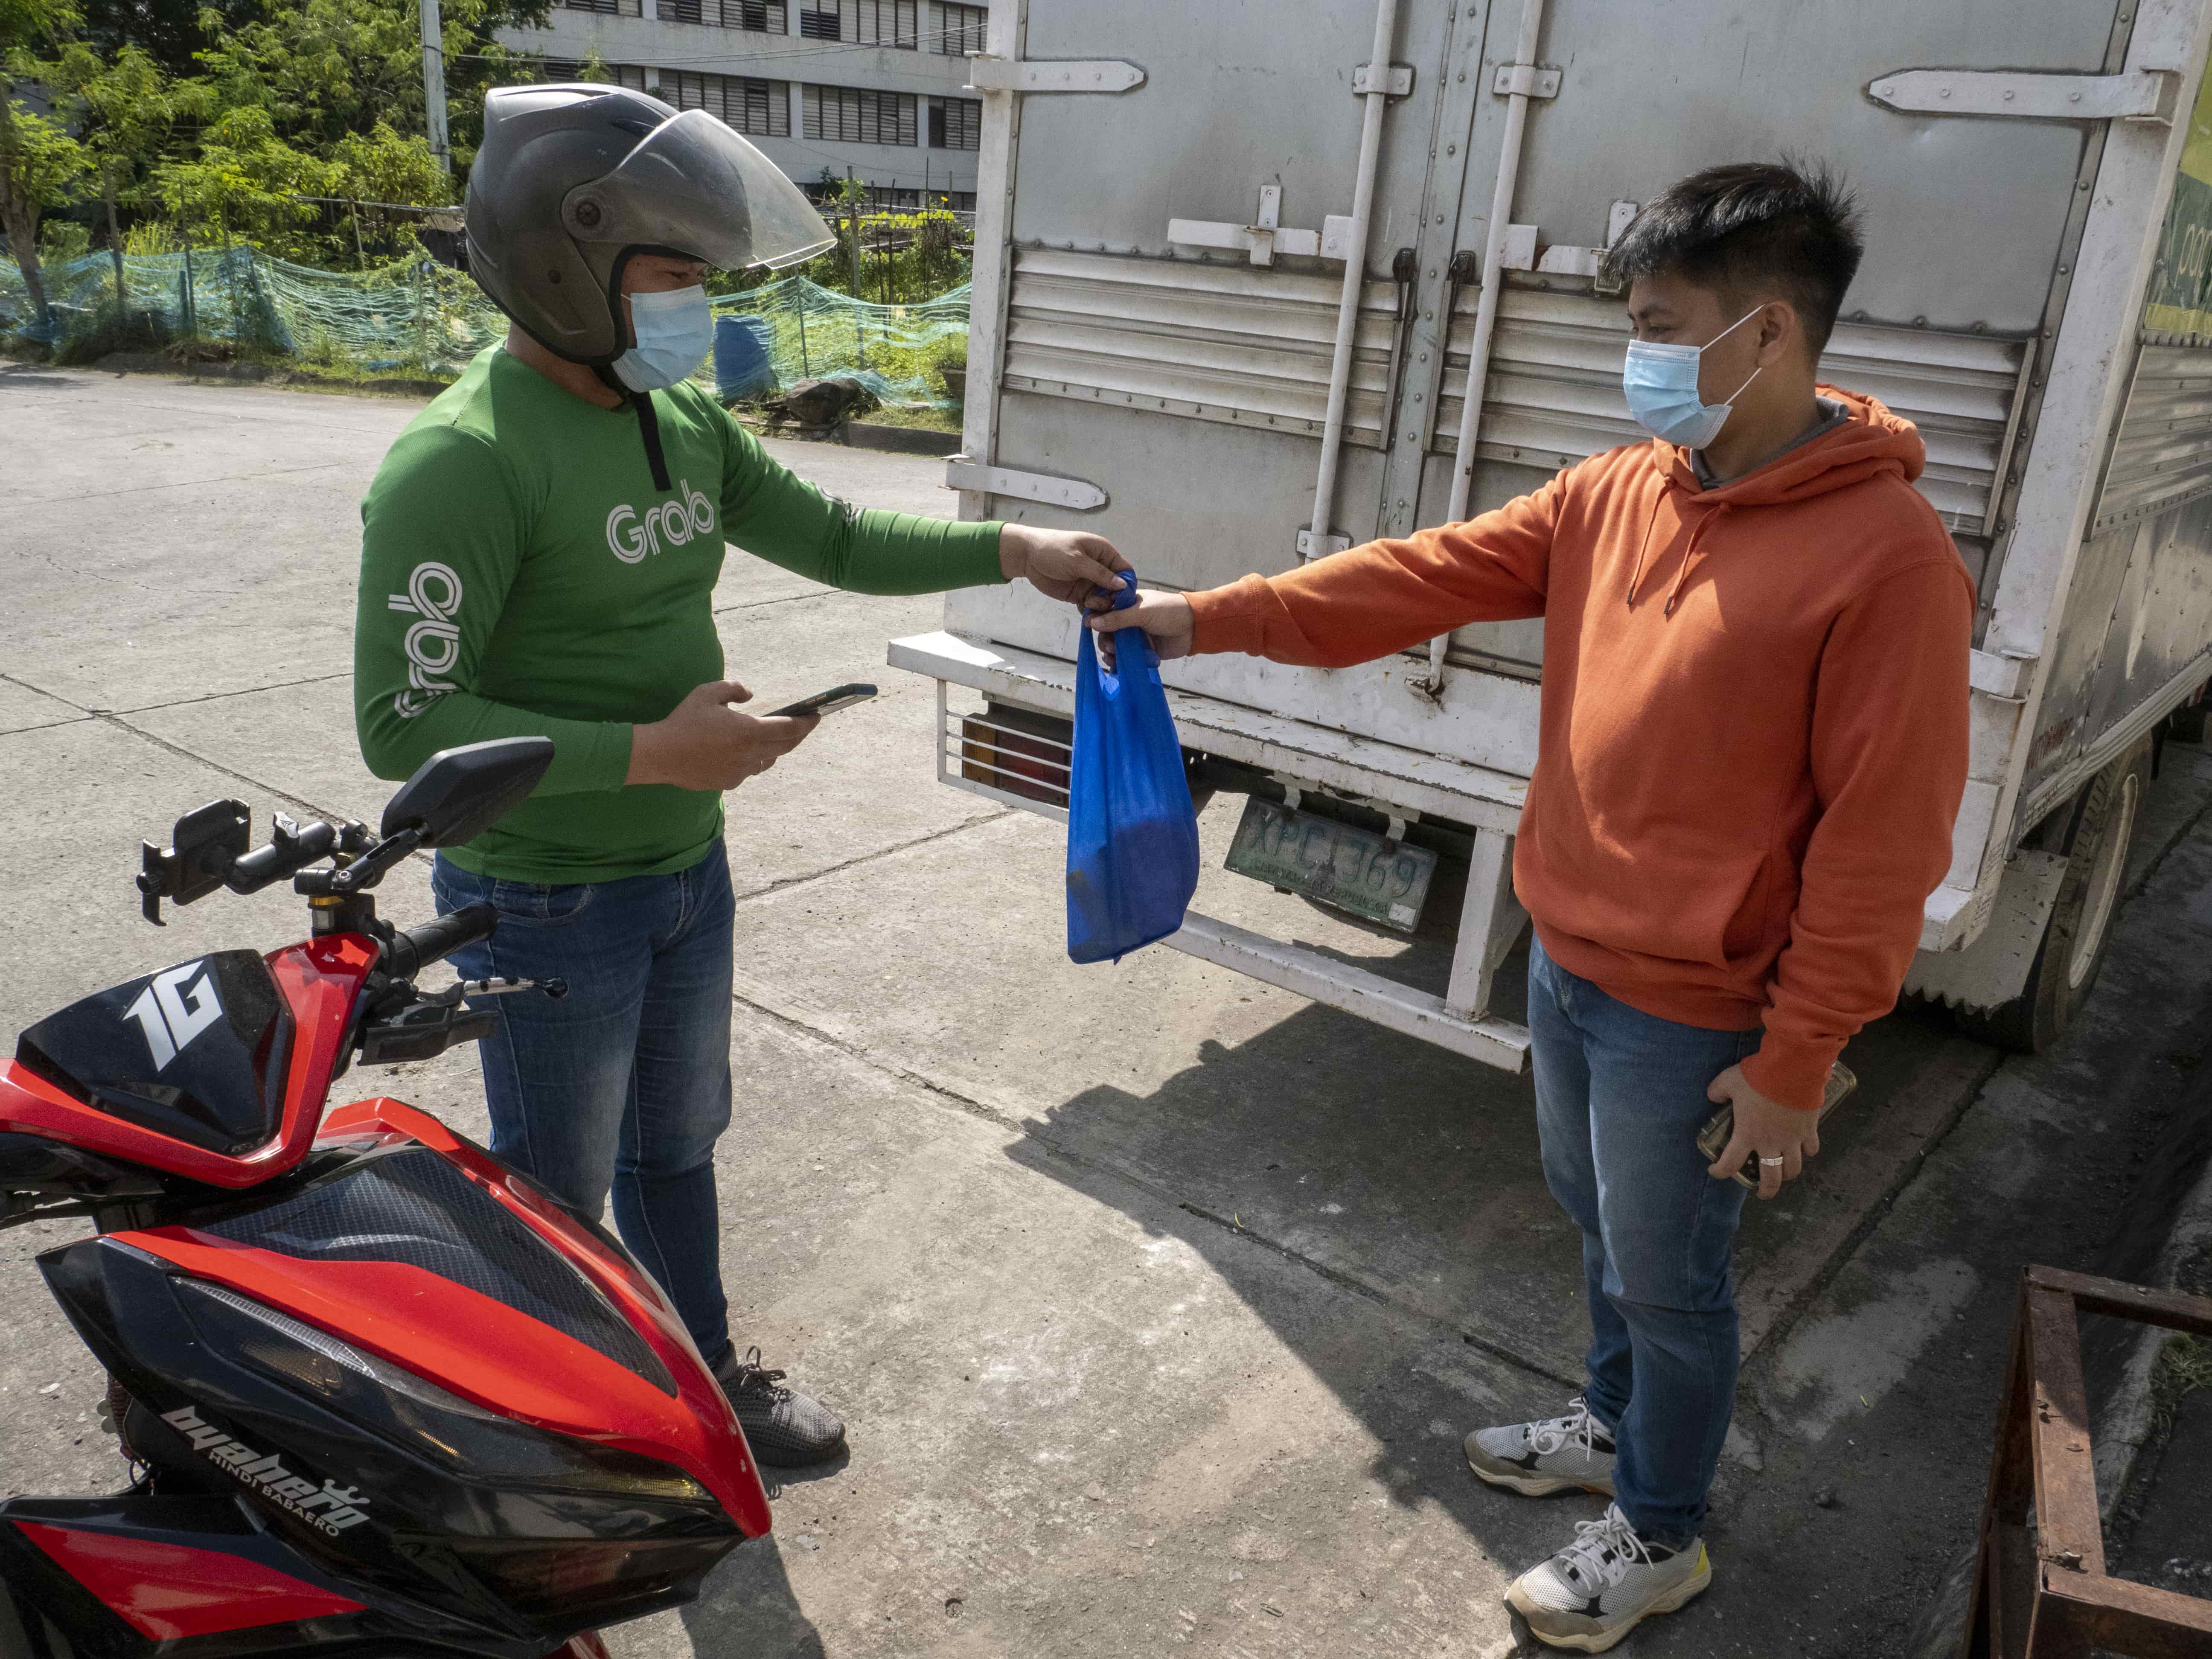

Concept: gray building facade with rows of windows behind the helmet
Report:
left=500, top=0, right=989, bottom=210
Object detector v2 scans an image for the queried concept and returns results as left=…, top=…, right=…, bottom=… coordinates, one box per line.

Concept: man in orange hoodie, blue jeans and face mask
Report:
left=1091, top=164, right=1975, bottom=1652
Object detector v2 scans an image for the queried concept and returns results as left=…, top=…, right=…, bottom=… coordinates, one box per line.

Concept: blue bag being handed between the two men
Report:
left=1068, top=573, right=1199, bottom=962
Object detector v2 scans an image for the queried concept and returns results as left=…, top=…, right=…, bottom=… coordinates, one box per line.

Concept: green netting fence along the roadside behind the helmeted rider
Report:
left=0, top=243, right=969, bottom=407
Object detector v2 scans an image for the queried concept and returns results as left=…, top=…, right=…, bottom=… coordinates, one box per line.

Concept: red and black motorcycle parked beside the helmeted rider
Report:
left=0, top=739, right=768, bottom=1659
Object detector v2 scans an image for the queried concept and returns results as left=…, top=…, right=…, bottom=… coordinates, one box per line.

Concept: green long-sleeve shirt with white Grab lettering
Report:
left=354, top=347, right=1002, bottom=882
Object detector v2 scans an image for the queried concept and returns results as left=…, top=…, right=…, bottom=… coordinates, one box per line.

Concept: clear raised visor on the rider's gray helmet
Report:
left=570, top=108, right=836, bottom=270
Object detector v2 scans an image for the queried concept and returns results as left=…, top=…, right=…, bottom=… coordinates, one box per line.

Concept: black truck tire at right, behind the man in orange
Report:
left=1958, top=739, right=2150, bottom=1055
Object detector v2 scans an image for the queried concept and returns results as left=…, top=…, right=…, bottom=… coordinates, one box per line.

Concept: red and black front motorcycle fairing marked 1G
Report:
left=0, top=934, right=378, bottom=1190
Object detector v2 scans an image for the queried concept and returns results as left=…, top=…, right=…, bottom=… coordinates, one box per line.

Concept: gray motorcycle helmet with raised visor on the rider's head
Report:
left=467, top=82, right=836, bottom=365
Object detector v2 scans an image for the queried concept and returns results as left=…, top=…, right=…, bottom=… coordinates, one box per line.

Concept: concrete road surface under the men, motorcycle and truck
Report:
left=0, top=365, right=2212, bottom=1659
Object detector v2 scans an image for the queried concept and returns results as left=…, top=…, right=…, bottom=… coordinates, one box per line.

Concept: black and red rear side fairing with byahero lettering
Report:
left=38, top=1141, right=765, bottom=1659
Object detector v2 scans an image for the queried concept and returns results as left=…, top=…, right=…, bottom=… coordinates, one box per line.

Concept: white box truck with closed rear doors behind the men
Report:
left=889, top=0, right=2212, bottom=1068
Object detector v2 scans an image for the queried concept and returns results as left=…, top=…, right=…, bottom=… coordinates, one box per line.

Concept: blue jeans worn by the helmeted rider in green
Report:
left=431, top=843, right=736, bottom=1362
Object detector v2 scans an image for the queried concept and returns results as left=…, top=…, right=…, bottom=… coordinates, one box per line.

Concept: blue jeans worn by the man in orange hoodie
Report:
left=1528, top=945, right=1758, bottom=1548
